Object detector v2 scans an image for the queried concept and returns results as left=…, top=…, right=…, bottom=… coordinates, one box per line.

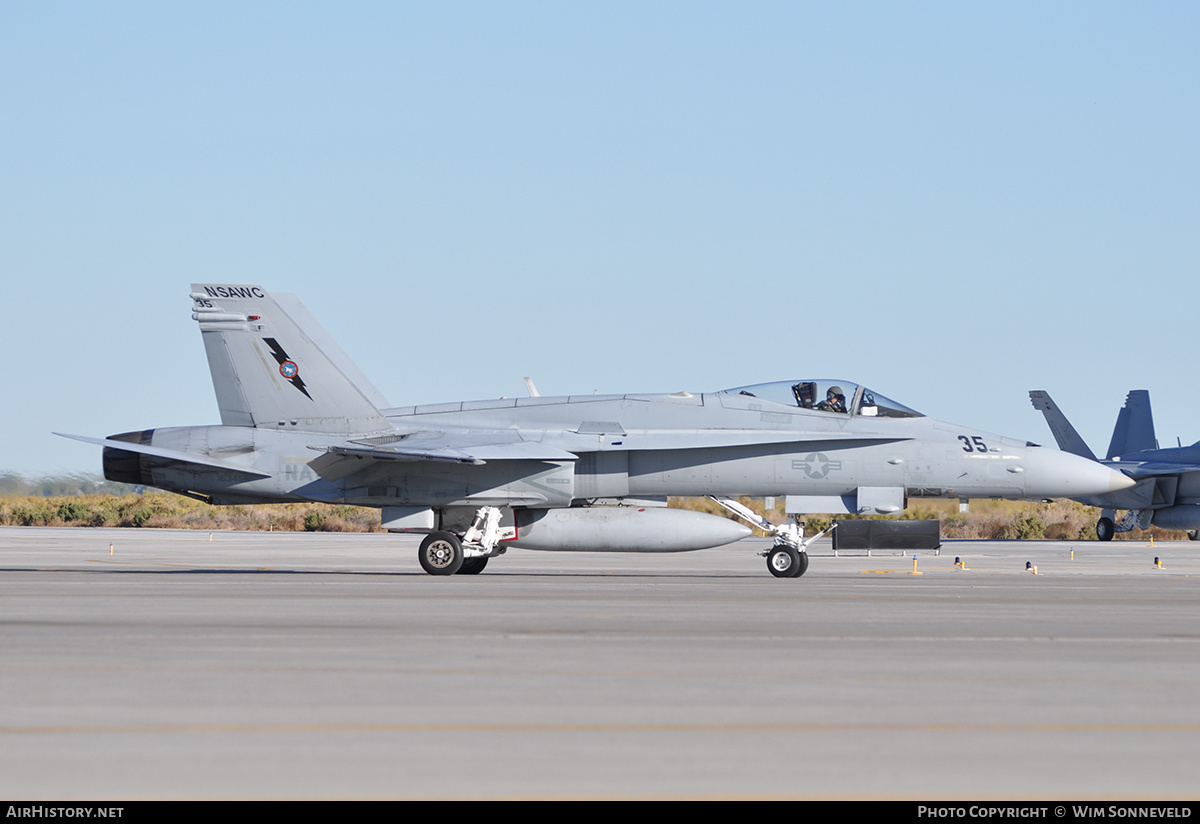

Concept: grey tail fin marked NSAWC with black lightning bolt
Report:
left=192, top=283, right=391, bottom=434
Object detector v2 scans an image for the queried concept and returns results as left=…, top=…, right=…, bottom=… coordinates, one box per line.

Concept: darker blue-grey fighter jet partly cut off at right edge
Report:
left=1030, top=389, right=1200, bottom=541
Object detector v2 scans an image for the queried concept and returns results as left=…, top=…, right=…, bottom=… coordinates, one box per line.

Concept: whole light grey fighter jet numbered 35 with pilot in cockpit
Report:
left=56, top=284, right=1132, bottom=577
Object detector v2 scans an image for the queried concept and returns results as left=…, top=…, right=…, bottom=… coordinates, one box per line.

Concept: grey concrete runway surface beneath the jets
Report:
left=0, top=528, right=1200, bottom=800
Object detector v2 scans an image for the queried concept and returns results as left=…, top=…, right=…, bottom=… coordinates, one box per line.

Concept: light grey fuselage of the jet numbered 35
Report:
left=106, top=391, right=1121, bottom=511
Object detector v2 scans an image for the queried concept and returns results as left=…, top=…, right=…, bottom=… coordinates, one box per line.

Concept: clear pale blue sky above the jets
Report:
left=0, top=2, right=1200, bottom=475
